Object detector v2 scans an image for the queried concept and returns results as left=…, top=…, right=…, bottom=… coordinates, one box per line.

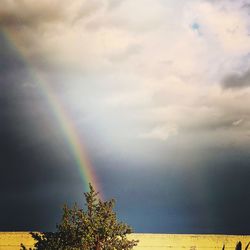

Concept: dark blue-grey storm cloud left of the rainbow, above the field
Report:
left=0, top=25, right=87, bottom=231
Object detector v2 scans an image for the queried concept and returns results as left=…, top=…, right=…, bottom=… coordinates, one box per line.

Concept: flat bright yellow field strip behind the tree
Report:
left=0, top=232, right=250, bottom=250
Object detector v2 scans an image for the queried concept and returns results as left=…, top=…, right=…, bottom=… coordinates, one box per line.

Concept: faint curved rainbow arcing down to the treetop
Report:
left=0, top=28, right=103, bottom=199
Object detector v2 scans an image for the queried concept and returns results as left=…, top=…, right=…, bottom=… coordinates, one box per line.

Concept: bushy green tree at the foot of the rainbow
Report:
left=21, top=184, right=138, bottom=250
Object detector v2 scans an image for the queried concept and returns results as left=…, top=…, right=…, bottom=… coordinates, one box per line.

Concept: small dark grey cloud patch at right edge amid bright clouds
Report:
left=221, top=70, right=250, bottom=89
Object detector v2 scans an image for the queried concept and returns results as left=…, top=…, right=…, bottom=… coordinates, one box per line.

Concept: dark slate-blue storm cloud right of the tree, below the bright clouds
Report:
left=99, top=145, right=250, bottom=234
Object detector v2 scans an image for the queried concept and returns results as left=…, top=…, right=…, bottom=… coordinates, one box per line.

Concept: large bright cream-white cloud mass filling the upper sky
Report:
left=2, top=0, right=250, bottom=150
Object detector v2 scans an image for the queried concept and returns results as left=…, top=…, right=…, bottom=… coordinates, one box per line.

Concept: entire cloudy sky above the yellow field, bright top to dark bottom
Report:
left=0, top=0, right=250, bottom=234
